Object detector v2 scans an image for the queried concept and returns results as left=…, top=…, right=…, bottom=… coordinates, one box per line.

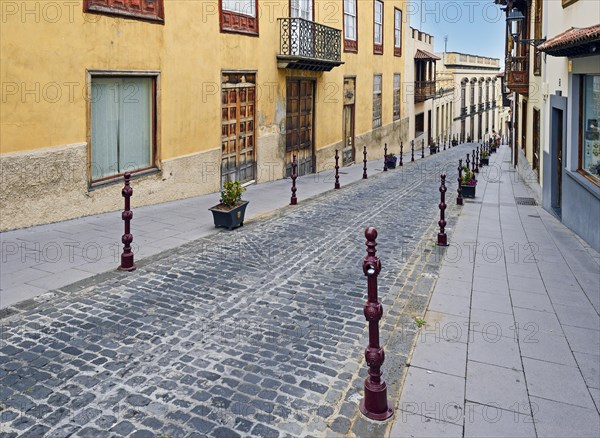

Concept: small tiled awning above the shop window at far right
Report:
left=538, top=24, right=600, bottom=58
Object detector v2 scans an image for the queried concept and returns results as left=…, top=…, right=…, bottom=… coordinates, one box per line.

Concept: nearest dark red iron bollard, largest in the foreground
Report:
left=360, top=227, right=394, bottom=421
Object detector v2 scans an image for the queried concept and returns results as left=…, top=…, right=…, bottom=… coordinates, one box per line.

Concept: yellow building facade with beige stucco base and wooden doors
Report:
left=0, top=0, right=409, bottom=230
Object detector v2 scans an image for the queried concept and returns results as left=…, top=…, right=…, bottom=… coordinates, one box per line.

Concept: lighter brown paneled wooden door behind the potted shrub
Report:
left=221, top=74, right=256, bottom=186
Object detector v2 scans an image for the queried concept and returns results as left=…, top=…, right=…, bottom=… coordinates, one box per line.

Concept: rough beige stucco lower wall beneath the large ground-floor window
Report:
left=0, top=143, right=220, bottom=231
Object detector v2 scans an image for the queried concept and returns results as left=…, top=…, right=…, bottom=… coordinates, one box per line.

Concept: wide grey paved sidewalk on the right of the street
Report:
left=389, top=148, right=600, bottom=438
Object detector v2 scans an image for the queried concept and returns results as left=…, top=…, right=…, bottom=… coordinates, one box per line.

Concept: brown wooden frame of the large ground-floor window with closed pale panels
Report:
left=86, top=69, right=161, bottom=188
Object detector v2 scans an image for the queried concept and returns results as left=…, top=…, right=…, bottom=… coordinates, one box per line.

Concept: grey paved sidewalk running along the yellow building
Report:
left=0, top=140, right=440, bottom=309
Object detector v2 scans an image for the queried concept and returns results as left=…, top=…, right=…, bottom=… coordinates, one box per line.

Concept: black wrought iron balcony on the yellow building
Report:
left=277, top=18, right=343, bottom=71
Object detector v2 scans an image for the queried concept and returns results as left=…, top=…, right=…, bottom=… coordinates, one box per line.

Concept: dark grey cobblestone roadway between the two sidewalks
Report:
left=0, top=145, right=472, bottom=437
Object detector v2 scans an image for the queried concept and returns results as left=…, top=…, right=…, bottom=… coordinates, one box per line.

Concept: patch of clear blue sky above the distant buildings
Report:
left=405, top=0, right=506, bottom=65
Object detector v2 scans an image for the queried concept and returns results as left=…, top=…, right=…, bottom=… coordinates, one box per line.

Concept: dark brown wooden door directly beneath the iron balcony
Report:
left=285, top=79, right=314, bottom=176
